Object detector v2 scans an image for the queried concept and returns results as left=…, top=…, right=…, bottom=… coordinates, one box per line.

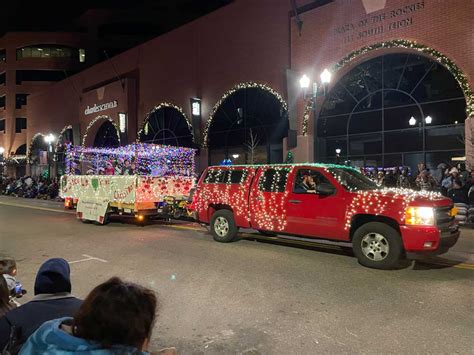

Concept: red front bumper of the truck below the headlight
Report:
left=400, top=224, right=460, bottom=253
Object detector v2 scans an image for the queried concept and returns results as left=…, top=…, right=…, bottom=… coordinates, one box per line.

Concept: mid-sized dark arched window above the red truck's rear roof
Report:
left=204, top=83, right=288, bottom=165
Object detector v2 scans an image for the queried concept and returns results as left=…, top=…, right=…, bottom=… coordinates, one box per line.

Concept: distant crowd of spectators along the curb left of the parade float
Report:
left=0, top=176, right=59, bottom=200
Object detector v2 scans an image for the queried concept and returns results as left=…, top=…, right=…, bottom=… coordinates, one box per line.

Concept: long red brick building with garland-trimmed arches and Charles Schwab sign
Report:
left=10, top=0, right=474, bottom=177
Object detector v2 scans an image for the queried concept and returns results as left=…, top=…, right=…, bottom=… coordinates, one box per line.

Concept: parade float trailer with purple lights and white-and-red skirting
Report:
left=60, top=144, right=196, bottom=224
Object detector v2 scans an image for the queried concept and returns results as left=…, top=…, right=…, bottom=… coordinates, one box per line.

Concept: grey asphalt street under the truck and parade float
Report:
left=0, top=198, right=474, bottom=354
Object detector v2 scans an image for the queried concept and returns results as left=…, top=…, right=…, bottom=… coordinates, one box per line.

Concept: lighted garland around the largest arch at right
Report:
left=302, top=39, right=474, bottom=136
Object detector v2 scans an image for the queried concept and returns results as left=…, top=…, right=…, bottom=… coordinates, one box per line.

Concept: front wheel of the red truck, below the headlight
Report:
left=352, top=222, right=404, bottom=269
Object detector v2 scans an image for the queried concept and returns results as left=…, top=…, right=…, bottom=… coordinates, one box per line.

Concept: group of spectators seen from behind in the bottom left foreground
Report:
left=0, top=258, right=176, bottom=355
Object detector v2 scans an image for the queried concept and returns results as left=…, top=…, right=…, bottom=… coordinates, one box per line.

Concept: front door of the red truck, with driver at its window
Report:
left=286, top=168, right=346, bottom=239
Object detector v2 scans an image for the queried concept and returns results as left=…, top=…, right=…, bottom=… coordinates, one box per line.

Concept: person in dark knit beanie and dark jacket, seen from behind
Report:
left=0, top=258, right=82, bottom=350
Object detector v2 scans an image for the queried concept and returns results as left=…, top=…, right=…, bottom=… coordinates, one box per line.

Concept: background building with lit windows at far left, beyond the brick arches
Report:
left=0, top=32, right=85, bottom=174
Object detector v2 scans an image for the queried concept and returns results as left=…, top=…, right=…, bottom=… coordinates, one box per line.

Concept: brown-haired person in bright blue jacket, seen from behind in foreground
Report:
left=20, top=277, right=157, bottom=355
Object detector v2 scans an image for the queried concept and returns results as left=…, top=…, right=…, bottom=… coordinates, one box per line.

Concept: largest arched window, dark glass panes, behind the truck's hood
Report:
left=315, top=53, right=466, bottom=169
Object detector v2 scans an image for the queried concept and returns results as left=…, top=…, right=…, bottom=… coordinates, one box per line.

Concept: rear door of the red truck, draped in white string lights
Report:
left=249, top=167, right=291, bottom=232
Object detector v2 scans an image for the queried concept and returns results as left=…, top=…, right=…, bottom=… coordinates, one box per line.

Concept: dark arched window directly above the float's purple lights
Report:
left=138, top=103, right=194, bottom=148
